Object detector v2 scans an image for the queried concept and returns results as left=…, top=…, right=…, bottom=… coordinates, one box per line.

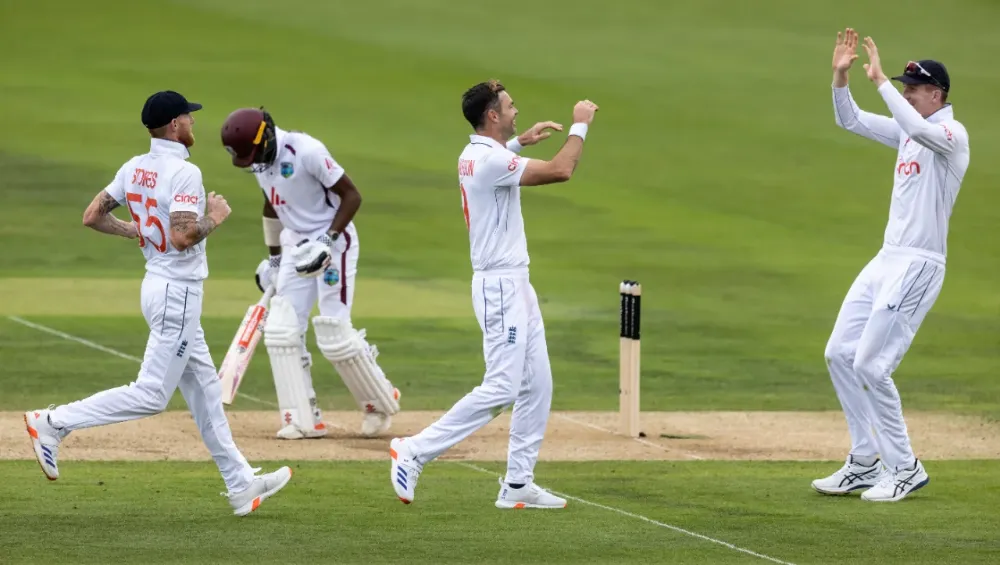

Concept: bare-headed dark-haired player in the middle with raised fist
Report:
left=389, top=81, right=597, bottom=508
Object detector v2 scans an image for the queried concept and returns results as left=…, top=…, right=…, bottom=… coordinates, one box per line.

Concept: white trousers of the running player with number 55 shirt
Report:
left=50, top=274, right=254, bottom=492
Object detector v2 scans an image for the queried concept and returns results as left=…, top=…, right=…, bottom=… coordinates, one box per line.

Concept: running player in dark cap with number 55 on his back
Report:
left=24, top=91, right=292, bottom=516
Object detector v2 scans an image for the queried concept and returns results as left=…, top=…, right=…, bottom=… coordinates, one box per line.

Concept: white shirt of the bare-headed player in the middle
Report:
left=458, top=135, right=530, bottom=272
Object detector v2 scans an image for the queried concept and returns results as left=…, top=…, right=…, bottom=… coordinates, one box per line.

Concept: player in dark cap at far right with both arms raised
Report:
left=812, top=28, right=969, bottom=501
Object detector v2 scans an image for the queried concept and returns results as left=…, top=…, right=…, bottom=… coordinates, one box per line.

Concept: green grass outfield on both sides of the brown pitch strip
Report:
left=0, top=0, right=1000, bottom=564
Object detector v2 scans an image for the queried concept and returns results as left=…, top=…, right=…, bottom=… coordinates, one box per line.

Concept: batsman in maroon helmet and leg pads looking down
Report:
left=222, top=108, right=400, bottom=439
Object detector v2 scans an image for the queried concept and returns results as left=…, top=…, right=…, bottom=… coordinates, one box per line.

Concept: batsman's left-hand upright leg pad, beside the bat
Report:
left=264, top=296, right=313, bottom=431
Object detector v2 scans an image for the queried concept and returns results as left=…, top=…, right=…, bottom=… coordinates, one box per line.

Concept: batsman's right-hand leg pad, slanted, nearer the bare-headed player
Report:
left=313, top=316, right=399, bottom=416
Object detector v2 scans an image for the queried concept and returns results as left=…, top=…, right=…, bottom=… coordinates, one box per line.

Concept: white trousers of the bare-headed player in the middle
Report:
left=408, top=270, right=552, bottom=484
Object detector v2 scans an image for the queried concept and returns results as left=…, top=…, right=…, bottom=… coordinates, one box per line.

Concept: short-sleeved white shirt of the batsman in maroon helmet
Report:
left=255, top=128, right=353, bottom=238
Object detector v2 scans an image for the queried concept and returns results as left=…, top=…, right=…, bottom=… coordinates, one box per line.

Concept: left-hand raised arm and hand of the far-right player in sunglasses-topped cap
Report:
left=833, top=28, right=901, bottom=149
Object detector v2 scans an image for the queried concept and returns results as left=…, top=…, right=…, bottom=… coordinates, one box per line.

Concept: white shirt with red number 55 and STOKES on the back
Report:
left=104, top=139, right=208, bottom=282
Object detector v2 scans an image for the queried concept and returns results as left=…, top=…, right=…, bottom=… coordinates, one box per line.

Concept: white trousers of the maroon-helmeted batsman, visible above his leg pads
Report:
left=277, top=224, right=358, bottom=399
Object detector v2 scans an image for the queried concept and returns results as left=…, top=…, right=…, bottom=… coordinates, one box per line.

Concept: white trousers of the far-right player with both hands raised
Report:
left=826, top=246, right=945, bottom=471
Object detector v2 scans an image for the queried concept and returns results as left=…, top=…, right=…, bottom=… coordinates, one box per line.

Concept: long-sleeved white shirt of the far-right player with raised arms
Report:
left=833, top=81, right=969, bottom=263
